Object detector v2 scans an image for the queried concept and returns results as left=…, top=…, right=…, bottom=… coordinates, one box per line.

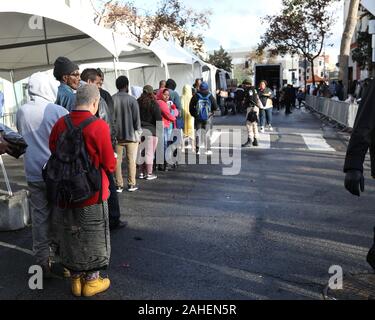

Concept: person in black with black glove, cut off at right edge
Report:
left=344, top=80, right=375, bottom=269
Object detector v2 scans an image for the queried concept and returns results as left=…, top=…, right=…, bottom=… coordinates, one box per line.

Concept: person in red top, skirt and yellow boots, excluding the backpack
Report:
left=49, top=85, right=116, bottom=297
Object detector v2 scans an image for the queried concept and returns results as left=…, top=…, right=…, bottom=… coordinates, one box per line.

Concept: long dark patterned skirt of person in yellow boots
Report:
left=59, top=202, right=111, bottom=272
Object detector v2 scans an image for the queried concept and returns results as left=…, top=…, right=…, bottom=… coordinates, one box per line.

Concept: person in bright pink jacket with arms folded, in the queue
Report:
left=156, top=89, right=179, bottom=171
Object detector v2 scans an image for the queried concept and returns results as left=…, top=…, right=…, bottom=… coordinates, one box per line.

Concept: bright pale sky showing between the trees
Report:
left=104, top=0, right=343, bottom=59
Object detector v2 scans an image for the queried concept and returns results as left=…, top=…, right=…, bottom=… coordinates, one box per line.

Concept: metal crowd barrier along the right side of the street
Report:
left=306, top=95, right=358, bottom=128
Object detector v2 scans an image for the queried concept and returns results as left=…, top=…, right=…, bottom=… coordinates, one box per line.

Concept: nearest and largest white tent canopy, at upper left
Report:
left=0, top=0, right=161, bottom=81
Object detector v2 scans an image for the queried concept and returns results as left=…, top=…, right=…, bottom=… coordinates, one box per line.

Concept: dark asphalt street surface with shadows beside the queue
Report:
left=0, top=106, right=375, bottom=300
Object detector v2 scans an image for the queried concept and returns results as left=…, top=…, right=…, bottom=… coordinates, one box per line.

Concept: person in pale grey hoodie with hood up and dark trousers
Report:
left=16, top=72, right=68, bottom=276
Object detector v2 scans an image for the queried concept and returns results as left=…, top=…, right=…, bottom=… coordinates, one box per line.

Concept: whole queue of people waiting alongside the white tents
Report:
left=17, top=57, right=217, bottom=297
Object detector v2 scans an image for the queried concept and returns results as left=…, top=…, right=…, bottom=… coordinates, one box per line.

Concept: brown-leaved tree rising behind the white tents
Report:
left=95, top=0, right=212, bottom=54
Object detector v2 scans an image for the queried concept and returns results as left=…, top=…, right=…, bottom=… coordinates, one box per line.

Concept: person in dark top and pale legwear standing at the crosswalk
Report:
left=242, top=80, right=262, bottom=148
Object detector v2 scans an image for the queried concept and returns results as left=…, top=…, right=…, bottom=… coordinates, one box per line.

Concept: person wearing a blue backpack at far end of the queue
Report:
left=189, top=82, right=218, bottom=155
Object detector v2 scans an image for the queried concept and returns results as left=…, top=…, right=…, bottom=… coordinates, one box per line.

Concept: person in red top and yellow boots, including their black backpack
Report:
left=47, top=84, right=116, bottom=297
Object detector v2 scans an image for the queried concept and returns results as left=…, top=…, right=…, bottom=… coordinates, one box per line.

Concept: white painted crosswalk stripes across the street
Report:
left=211, top=130, right=336, bottom=152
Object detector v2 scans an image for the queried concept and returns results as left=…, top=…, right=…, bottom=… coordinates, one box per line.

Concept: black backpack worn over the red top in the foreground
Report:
left=43, top=115, right=102, bottom=207
